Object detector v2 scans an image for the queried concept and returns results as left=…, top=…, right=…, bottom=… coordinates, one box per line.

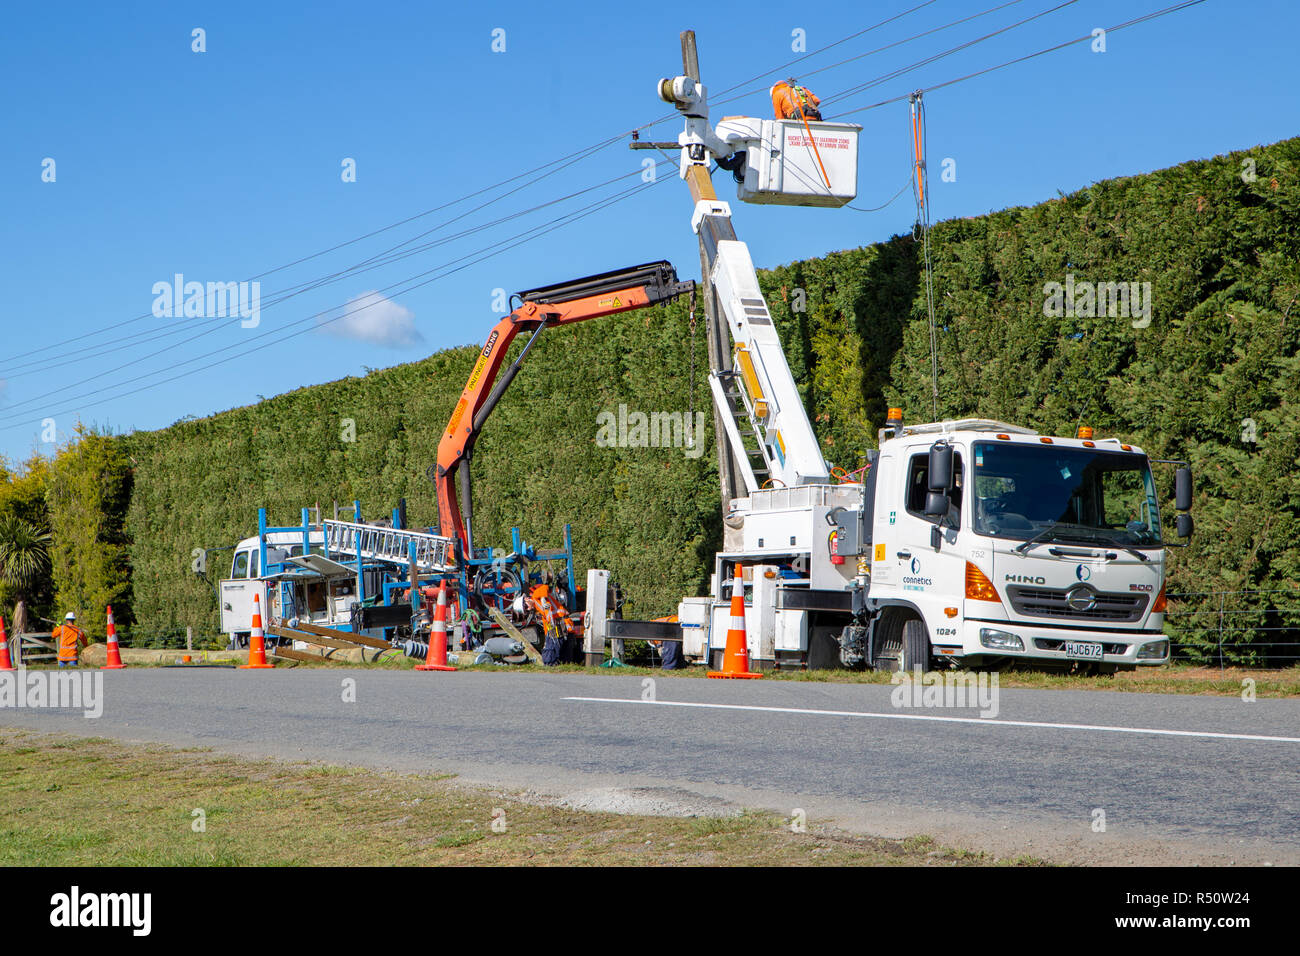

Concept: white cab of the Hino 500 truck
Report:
left=836, top=414, right=1192, bottom=672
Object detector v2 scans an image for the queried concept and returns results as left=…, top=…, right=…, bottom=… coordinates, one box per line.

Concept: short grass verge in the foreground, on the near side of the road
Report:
left=0, top=731, right=1039, bottom=866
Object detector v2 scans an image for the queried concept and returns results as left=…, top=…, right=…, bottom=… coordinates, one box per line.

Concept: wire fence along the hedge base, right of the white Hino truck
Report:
left=1165, top=588, right=1300, bottom=669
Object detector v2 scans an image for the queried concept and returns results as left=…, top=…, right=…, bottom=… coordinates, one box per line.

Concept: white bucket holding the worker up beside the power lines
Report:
left=718, top=116, right=862, bottom=207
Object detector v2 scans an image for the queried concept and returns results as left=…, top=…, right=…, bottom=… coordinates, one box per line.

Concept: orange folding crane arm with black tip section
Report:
left=434, top=260, right=696, bottom=558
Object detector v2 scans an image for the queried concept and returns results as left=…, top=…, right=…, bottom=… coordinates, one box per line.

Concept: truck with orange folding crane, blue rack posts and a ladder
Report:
left=217, top=260, right=696, bottom=659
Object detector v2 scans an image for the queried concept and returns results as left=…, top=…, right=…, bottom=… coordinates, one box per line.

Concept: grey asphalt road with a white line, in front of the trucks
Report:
left=0, top=669, right=1300, bottom=864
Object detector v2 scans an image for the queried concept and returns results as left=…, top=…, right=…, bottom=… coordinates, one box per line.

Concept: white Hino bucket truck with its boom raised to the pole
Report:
left=588, top=31, right=1192, bottom=672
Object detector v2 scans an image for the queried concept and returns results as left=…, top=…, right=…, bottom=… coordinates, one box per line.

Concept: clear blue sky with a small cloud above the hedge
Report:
left=0, top=0, right=1300, bottom=460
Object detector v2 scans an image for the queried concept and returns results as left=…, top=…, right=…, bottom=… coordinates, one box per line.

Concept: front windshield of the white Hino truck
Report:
left=974, top=442, right=1161, bottom=548
